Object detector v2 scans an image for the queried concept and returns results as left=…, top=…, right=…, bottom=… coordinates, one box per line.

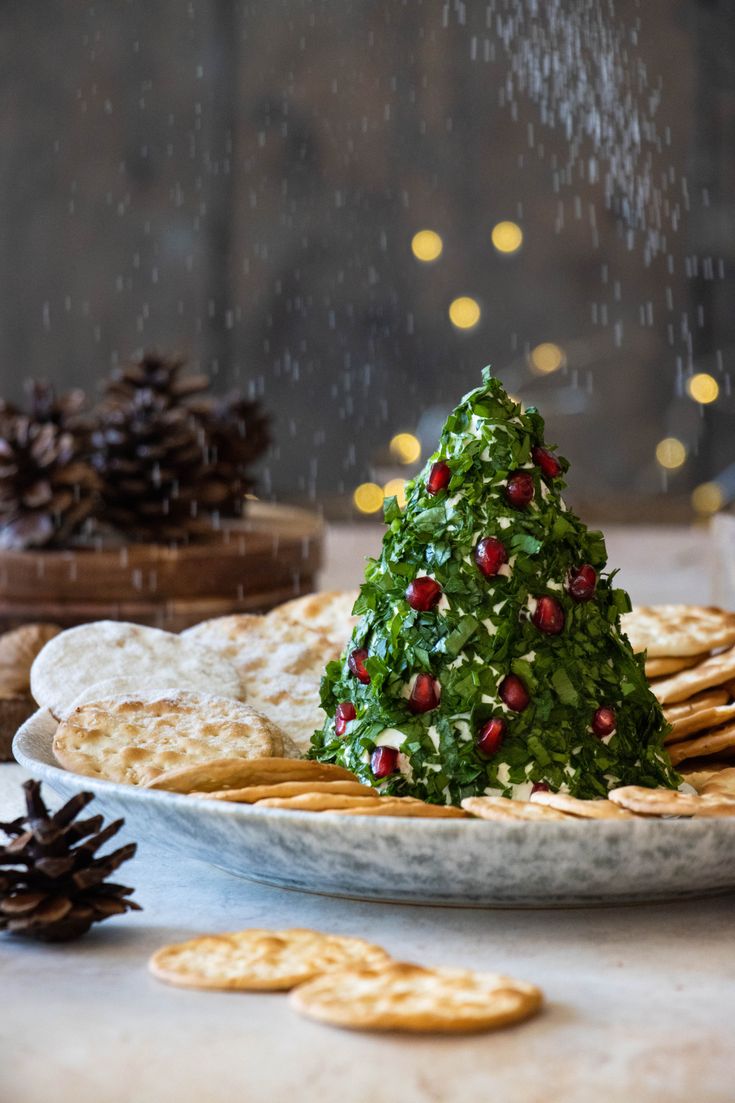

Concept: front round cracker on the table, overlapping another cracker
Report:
left=289, top=962, right=543, bottom=1034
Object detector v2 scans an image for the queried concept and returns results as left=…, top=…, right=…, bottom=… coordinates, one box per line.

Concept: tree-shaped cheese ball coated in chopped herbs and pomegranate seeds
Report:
left=311, top=368, right=679, bottom=804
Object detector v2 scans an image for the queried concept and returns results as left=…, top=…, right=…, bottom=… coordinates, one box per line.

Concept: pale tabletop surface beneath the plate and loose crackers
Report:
left=0, top=526, right=735, bottom=1103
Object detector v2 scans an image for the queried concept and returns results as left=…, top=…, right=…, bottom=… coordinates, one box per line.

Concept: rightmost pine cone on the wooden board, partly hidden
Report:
left=199, top=394, right=270, bottom=517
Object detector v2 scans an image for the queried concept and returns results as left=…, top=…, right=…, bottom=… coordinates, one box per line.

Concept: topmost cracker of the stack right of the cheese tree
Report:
left=621, top=604, right=735, bottom=658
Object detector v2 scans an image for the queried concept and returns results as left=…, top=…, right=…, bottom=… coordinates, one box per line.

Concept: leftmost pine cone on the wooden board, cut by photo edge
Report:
left=0, top=407, right=97, bottom=549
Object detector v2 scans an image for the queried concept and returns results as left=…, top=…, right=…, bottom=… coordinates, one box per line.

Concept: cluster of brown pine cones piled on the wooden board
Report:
left=0, top=353, right=270, bottom=548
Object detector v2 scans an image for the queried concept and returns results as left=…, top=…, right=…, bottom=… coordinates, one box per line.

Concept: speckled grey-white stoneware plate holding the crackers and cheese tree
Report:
left=13, top=710, right=735, bottom=908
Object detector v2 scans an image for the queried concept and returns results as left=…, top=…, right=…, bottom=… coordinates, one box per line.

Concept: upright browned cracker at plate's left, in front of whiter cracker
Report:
left=53, top=693, right=283, bottom=785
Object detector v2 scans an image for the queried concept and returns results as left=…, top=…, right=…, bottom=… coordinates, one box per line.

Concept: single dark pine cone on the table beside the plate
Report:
left=0, top=781, right=140, bottom=942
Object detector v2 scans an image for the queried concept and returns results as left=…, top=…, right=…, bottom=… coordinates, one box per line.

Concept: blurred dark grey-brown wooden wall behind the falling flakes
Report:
left=0, top=0, right=735, bottom=521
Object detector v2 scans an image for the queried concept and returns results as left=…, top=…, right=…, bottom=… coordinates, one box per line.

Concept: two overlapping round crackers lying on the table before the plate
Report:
left=149, top=928, right=543, bottom=1034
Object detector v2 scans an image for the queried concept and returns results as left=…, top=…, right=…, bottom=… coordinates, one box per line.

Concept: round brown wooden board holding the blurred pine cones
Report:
left=0, top=502, right=323, bottom=631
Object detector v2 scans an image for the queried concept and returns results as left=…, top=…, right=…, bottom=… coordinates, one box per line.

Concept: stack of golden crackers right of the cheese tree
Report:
left=622, top=604, right=735, bottom=777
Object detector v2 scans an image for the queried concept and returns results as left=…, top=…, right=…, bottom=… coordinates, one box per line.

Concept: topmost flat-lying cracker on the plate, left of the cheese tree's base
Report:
left=148, top=757, right=358, bottom=793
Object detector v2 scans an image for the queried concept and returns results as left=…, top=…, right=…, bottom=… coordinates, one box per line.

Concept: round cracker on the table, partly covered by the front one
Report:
left=149, top=928, right=392, bottom=992
